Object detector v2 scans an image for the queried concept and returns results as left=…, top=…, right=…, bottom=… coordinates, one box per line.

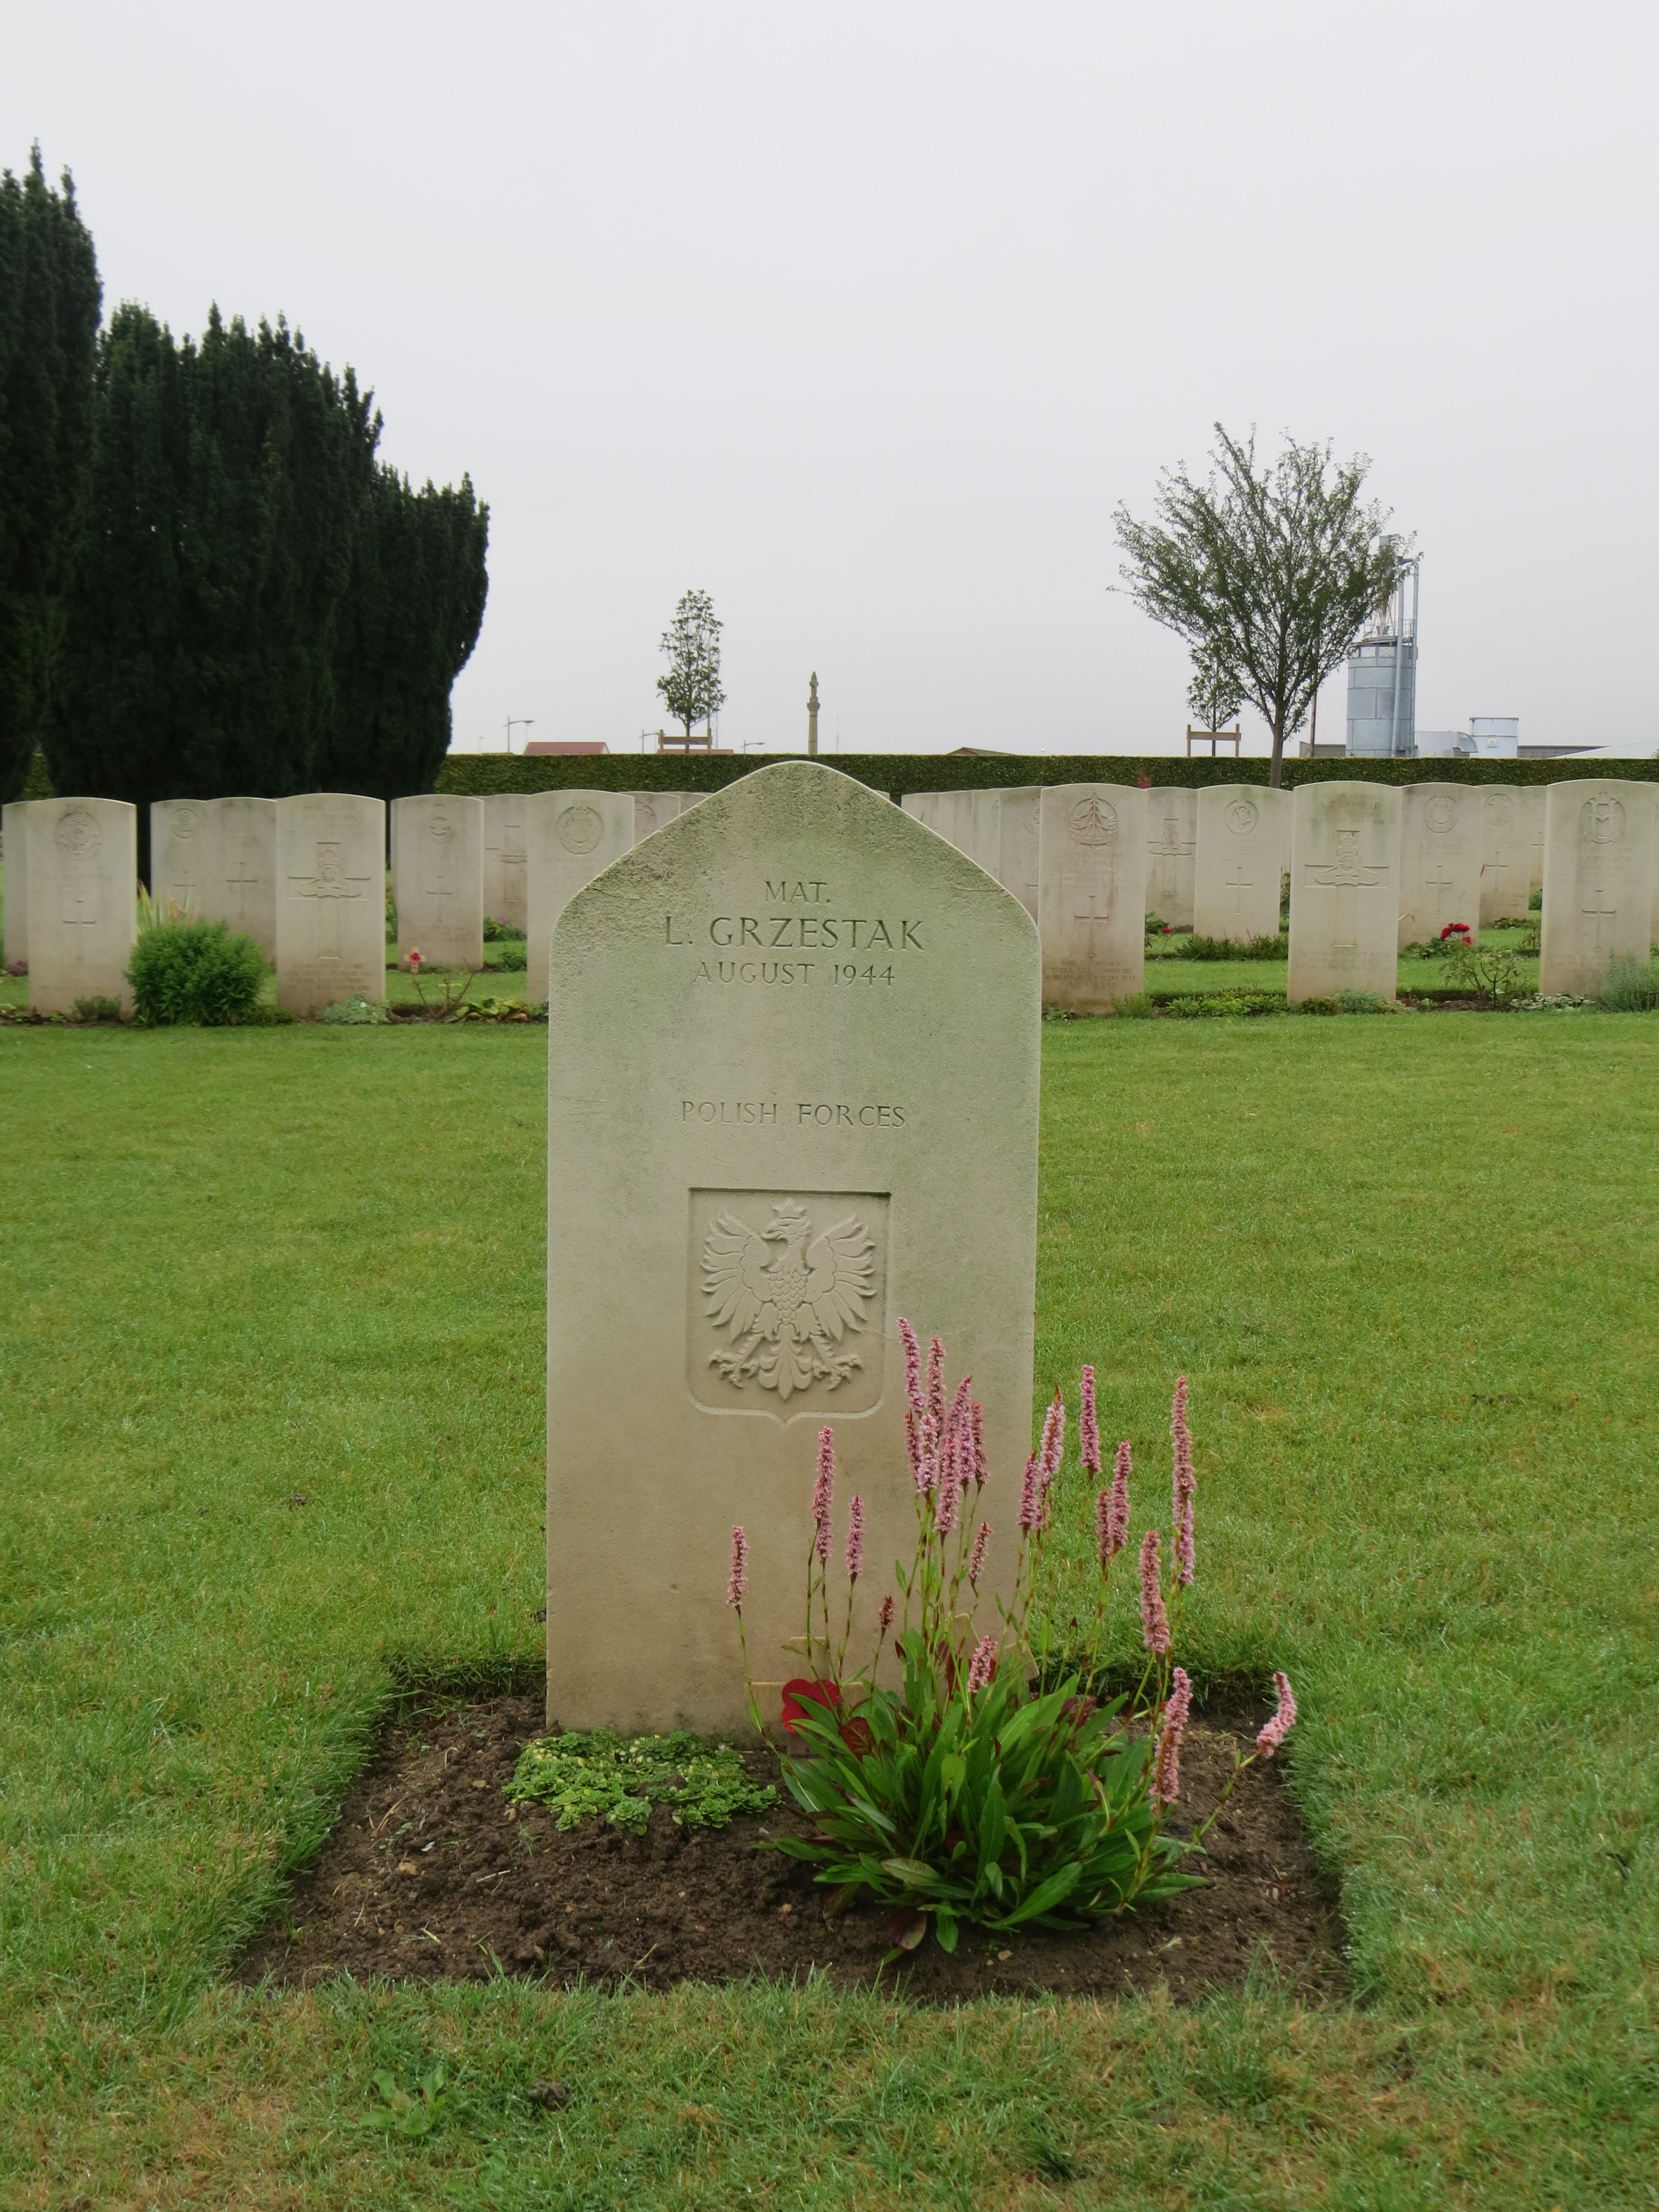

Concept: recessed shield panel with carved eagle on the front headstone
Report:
left=688, top=1190, right=887, bottom=1420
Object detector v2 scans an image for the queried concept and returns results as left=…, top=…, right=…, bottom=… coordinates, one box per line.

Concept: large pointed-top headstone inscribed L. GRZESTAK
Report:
left=546, top=761, right=1040, bottom=1732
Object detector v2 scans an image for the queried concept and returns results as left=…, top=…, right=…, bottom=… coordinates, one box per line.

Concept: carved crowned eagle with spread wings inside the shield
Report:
left=703, top=1199, right=876, bottom=1405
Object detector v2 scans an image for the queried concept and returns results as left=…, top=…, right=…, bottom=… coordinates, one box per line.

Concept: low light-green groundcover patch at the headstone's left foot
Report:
left=507, top=1728, right=779, bottom=1836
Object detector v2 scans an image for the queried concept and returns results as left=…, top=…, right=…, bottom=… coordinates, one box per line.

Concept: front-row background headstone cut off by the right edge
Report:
left=1537, top=776, right=1655, bottom=998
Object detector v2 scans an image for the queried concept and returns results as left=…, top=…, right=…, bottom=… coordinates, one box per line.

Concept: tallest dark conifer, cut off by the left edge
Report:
left=0, top=146, right=102, bottom=799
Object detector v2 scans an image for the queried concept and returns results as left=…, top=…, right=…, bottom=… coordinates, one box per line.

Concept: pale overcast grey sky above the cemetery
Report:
left=0, top=0, right=1659, bottom=752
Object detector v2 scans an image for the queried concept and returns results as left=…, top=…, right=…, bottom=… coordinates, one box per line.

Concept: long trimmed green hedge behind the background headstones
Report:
left=434, top=752, right=1659, bottom=799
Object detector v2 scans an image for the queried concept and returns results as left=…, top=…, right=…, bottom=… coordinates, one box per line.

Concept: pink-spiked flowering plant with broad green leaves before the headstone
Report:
left=726, top=1321, right=1296, bottom=1951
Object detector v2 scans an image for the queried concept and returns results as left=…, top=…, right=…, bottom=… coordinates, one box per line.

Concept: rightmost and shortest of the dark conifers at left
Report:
left=316, top=465, right=489, bottom=799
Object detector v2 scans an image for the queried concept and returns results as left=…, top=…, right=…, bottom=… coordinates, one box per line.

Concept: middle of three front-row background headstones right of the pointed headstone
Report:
left=1285, top=783, right=1400, bottom=1006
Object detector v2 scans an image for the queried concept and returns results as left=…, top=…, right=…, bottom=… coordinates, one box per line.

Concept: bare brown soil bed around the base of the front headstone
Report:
left=239, top=1697, right=1343, bottom=2002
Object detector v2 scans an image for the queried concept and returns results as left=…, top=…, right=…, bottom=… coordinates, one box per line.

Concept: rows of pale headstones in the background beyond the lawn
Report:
left=4, top=779, right=1659, bottom=1015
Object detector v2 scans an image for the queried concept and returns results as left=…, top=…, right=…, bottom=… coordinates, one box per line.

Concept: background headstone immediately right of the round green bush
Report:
left=276, top=792, right=385, bottom=1015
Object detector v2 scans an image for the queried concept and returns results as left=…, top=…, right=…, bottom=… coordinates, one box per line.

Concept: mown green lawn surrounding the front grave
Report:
left=0, top=1013, right=1659, bottom=2212
